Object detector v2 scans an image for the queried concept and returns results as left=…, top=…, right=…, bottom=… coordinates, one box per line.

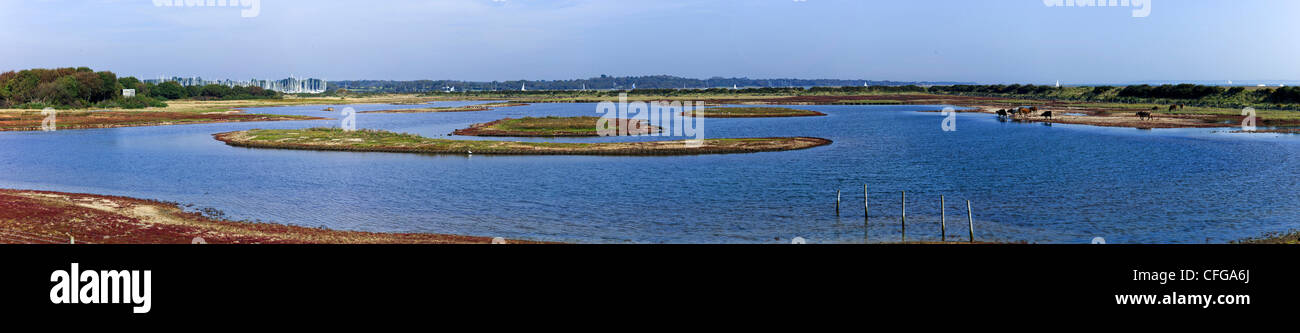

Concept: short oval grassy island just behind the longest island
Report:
left=452, top=117, right=663, bottom=137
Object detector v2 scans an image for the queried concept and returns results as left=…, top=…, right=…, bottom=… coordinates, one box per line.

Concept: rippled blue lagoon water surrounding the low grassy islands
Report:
left=0, top=101, right=1300, bottom=243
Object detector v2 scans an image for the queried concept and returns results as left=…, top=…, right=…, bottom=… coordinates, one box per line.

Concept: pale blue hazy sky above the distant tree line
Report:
left=0, top=0, right=1300, bottom=83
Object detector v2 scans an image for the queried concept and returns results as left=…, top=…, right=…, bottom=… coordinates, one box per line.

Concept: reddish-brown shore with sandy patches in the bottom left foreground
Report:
left=0, top=190, right=532, bottom=245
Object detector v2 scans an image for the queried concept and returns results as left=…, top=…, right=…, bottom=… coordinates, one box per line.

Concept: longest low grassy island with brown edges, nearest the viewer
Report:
left=213, top=127, right=831, bottom=156
